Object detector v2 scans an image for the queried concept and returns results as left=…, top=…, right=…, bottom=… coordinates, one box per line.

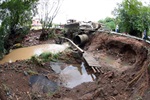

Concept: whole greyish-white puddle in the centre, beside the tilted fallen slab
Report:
left=50, top=63, right=96, bottom=88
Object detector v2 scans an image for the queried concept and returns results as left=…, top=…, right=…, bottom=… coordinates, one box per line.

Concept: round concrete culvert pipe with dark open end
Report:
left=74, top=34, right=89, bottom=45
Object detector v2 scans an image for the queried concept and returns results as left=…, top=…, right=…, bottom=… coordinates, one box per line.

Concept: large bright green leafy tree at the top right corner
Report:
left=113, top=0, right=150, bottom=37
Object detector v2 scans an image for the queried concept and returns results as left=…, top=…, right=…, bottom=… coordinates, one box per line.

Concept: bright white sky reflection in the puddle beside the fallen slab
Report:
left=51, top=63, right=96, bottom=88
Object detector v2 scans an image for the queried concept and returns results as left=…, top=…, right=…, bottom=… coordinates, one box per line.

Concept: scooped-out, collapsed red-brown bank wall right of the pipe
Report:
left=86, top=33, right=148, bottom=66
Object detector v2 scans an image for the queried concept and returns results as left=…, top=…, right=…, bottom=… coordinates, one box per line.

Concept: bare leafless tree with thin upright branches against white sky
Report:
left=37, top=0, right=63, bottom=38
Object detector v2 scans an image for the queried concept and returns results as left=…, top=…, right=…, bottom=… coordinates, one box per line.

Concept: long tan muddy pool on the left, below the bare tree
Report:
left=0, top=43, right=69, bottom=64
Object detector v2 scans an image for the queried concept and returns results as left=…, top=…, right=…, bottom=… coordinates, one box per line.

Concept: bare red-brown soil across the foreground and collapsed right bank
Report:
left=0, top=32, right=150, bottom=100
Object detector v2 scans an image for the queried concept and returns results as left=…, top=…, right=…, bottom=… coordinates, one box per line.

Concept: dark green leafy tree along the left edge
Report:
left=0, top=0, right=38, bottom=58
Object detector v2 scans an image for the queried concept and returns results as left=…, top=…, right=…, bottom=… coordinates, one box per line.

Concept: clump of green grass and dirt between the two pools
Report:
left=30, top=50, right=81, bottom=66
